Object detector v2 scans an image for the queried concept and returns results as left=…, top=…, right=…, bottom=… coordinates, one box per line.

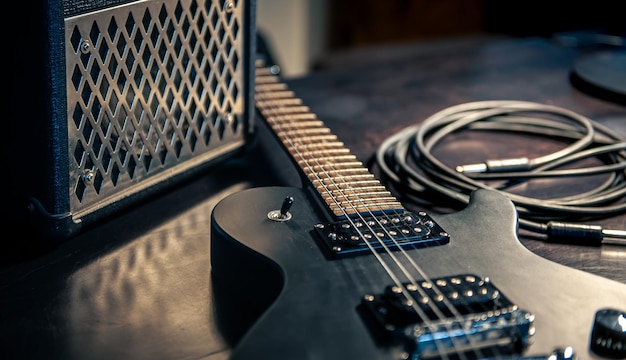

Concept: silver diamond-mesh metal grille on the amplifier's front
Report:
left=65, top=0, right=247, bottom=215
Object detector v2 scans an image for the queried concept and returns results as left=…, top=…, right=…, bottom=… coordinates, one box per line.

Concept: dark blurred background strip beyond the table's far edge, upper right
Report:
left=328, top=0, right=626, bottom=49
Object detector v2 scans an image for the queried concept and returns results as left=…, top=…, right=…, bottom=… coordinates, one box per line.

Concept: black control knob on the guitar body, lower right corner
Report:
left=589, top=309, right=626, bottom=359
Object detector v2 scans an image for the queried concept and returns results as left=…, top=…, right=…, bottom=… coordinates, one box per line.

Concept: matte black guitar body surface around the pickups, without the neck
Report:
left=211, top=187, right=626, bottom=360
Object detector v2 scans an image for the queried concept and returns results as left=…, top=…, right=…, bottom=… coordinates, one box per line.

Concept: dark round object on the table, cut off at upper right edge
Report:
left=570, top=50, right=626, bottom=105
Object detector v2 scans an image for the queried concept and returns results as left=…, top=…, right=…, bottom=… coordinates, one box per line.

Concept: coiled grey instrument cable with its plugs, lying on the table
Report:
left=375, top=100, right=626, bottom=246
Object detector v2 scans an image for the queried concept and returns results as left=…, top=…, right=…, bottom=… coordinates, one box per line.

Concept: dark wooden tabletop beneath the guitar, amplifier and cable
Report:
left=0, top=34, right=626, bottom=359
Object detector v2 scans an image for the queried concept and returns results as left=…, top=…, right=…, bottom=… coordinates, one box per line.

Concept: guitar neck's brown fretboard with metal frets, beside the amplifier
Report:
left=254, top=62, right=403, bottom=218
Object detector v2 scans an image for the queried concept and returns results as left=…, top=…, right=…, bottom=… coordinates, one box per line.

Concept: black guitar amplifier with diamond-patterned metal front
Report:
left=3, top=0, right=256, bottom=240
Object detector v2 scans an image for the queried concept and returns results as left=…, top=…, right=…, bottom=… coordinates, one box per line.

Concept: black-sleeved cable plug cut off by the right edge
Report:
left=546, top=221, right=626, bottom=246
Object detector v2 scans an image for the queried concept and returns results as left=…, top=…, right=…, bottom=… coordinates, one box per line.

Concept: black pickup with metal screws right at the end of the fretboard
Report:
left=315, top=212, right=450, bottom=257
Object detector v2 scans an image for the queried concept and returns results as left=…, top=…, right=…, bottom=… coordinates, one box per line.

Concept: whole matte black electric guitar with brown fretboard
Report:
left=211, top=61, right=626, bottom=360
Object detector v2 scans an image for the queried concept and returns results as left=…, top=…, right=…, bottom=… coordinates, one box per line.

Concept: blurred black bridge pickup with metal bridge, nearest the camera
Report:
left=361, top=274, right=534, bottom=359
